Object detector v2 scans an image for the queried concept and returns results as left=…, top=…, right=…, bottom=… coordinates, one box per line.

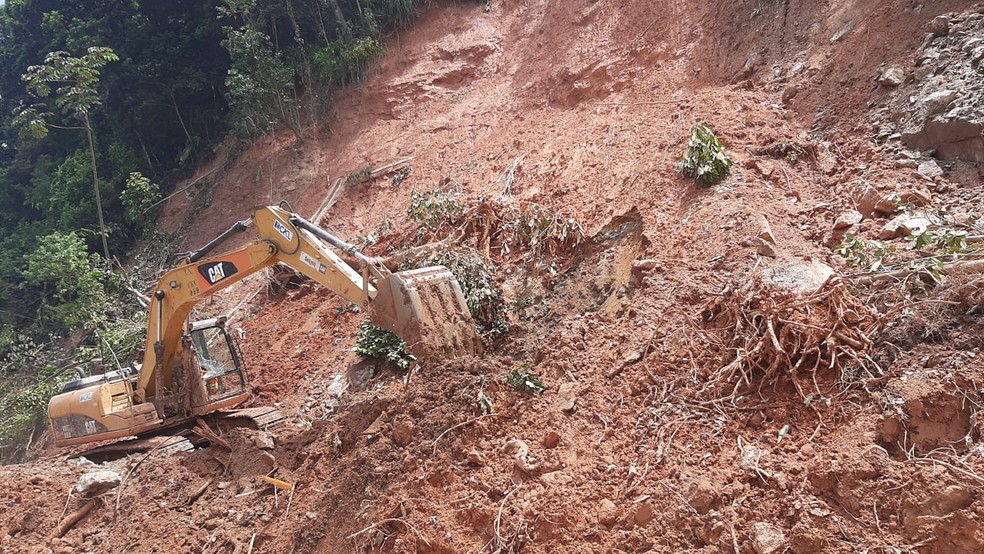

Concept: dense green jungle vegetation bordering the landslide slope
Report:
left=0, top=0, right=428, bottom=460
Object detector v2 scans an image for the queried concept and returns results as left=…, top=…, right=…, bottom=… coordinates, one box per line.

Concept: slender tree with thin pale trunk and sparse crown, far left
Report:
left=18, top=46, right=119, bottom=259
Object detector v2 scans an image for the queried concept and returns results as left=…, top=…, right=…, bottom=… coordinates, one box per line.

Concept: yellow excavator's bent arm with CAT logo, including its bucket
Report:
left=135, top=206, right=482, bottom=402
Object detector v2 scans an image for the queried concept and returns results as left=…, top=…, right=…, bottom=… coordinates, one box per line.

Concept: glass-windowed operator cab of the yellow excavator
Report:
left=189, top=319, right=246, bottom=403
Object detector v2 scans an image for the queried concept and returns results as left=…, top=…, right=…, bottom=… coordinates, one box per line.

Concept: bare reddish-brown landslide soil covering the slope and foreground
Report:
left=0, top=0, right=984, bottom=554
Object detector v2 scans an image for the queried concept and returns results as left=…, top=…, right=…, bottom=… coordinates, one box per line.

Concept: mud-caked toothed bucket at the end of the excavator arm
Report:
left=369, top=266, right=482, bottom=359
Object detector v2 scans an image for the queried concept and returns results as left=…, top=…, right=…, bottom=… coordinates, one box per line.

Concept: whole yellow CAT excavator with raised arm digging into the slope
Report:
left=48, top=203, right=482, bottom=446
